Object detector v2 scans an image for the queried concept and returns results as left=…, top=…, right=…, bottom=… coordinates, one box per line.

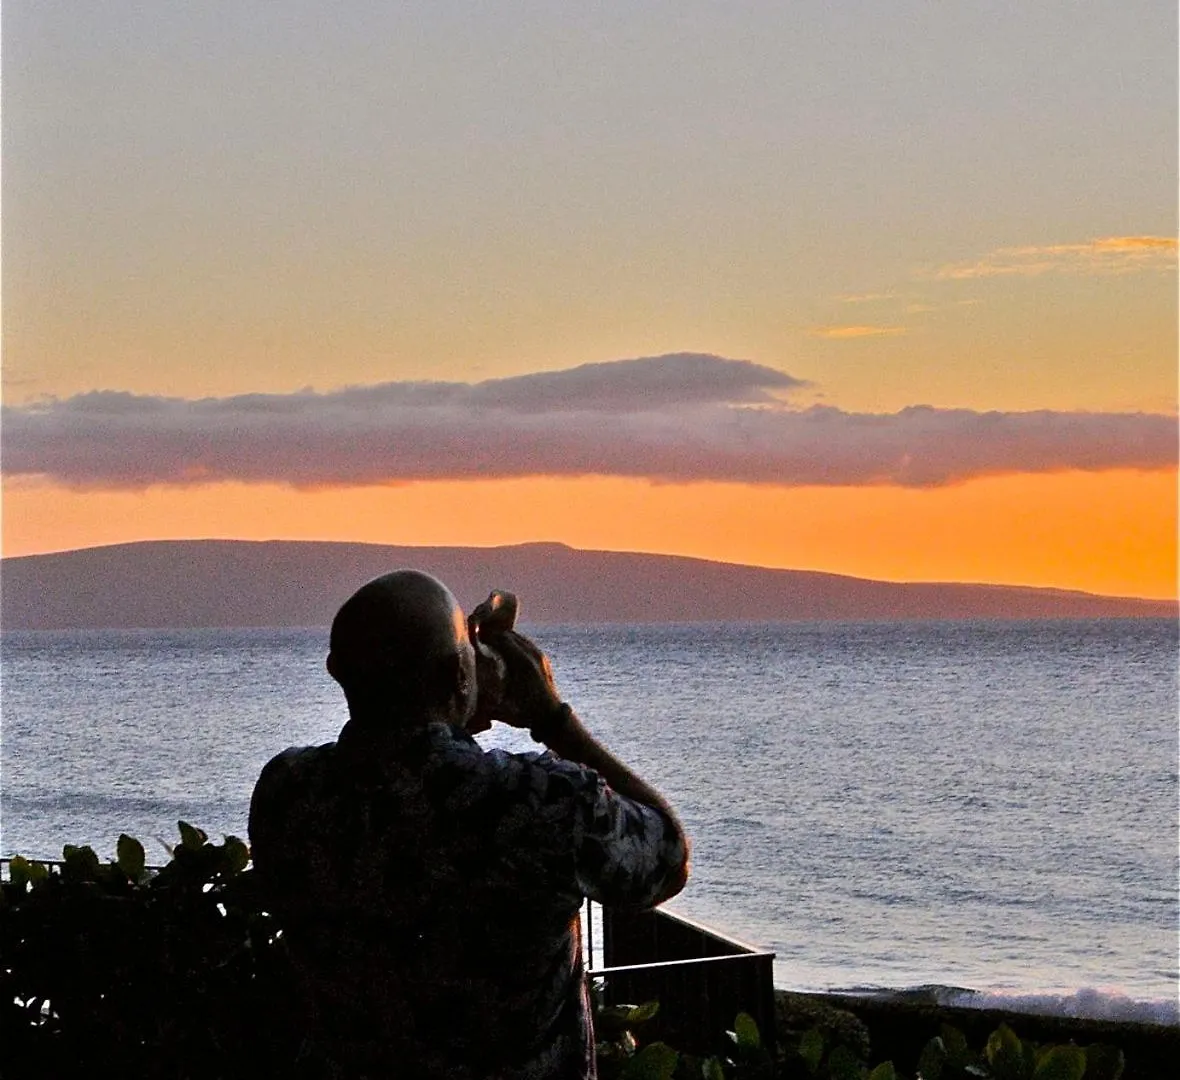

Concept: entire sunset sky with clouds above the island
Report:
left=0, top=0, right=1178, bottom=597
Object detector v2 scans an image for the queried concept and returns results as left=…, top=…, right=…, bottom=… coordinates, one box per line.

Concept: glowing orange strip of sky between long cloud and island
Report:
left=4, top=471, right=1176, bottom=598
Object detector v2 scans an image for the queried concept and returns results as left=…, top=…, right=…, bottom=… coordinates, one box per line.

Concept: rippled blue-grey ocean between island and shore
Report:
left=0, top=620, right=1180, bottom=1023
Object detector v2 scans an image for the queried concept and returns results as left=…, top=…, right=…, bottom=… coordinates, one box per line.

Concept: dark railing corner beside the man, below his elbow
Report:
left=585, top=905, right=774, bottom=1054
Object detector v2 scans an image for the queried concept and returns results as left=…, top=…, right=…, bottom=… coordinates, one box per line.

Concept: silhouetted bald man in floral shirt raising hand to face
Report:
left=250, top=570, right=688, bottom=1080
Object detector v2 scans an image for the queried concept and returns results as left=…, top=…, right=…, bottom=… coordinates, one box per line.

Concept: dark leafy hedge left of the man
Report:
left=0, top=822, right=297, bottom=1078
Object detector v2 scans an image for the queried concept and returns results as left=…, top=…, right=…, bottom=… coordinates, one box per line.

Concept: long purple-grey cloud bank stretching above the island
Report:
left=2, top=354, right=1176, bottom=489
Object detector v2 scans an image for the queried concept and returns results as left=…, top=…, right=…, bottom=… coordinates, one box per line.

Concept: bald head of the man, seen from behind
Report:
left=328, top=570, right=474, bottom=724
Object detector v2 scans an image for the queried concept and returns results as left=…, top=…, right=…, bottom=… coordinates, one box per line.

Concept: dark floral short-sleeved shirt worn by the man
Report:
left=250, top=724, right=687, bottom=1080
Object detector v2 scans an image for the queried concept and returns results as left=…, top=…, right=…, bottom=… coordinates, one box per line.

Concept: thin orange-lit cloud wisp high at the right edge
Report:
left=935, top=236, right=1176, bottom=281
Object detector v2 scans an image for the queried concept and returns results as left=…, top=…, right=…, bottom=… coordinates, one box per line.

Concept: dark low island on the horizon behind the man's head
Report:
left=0, top=541, right=1178, bottom=630
